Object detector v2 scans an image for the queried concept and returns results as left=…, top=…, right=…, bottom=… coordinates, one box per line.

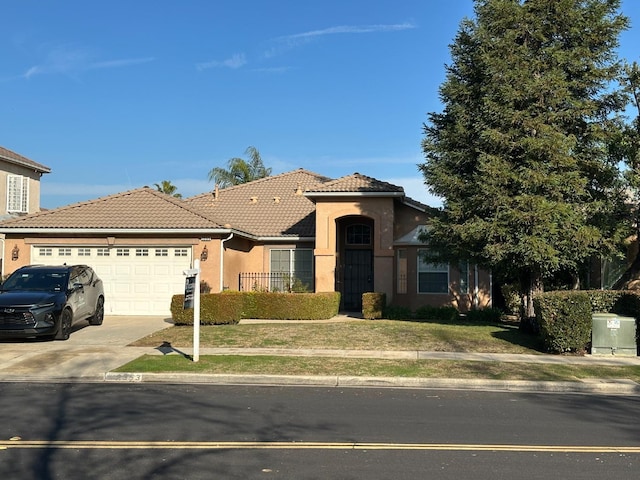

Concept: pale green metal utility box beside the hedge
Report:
left=591, top=313, right=638, bottom=356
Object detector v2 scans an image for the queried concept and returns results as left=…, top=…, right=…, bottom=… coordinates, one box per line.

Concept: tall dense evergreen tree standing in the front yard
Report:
left=419, top=0, right=628, bottom=326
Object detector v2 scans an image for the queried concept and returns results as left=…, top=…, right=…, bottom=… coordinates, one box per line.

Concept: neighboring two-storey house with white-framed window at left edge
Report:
left=0, top=147, right=51, bottom=219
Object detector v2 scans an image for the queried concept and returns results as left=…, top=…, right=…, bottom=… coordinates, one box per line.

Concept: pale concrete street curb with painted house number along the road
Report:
left=104, top=372, right=640, bottom=396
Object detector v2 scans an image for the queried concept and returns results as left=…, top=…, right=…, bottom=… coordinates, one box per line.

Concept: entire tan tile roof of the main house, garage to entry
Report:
left=0, top=169, right=422, bottom=238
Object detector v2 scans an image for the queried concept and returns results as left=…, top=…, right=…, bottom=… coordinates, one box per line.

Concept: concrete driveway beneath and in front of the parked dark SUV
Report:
left=0, top=316, right=173, bottom=381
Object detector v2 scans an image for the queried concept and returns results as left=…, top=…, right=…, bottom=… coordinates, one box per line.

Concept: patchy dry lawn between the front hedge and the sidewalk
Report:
left=132, top=320, right=540, bottom=353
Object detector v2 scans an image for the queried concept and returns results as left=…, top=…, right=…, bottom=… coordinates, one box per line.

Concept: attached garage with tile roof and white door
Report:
left=0, top=187, right=228, bottom=317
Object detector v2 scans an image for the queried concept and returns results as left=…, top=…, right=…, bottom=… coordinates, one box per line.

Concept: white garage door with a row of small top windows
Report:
left=31, top=246, right=191, bottom=316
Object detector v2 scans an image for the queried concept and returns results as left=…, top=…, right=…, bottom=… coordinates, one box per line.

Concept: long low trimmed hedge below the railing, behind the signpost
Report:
left=171, top=291, right=340, bottom=325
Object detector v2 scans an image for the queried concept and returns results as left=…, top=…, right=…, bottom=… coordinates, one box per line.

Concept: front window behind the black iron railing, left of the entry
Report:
left=270, top=248, right=313, bottom=291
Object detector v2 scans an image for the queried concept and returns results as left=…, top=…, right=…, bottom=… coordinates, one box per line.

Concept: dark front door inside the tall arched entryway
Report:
left=342, top=249, right=373, bottom=311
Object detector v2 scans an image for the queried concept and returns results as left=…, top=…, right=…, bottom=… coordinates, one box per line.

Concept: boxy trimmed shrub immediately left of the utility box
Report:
left=533, top=290, right=592, bottom=353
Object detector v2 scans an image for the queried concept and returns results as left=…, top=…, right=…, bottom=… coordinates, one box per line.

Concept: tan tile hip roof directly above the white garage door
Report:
left=0, top=187, right=221, bottom=232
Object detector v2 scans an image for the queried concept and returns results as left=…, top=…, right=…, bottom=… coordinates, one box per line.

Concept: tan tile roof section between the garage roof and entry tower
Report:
left=185, top=169, right=331, bottom=237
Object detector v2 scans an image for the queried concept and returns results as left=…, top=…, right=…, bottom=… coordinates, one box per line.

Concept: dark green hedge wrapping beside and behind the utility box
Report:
left=534, top=290, right=640, bottom=353
